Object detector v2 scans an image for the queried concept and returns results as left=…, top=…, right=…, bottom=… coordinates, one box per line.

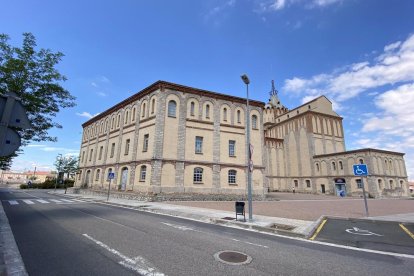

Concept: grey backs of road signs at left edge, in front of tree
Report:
left=0, top=93, right=30, bottom=156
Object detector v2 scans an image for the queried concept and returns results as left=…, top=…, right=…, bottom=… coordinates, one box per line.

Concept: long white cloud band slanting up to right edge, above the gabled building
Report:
left=284, top=35, right=414, bottom=103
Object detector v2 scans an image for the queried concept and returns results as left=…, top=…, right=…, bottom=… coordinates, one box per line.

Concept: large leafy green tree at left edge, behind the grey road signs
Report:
left=0, top=33, right=75, bottom=166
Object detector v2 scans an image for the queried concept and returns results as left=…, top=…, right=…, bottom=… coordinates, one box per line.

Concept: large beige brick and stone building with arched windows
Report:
left=76, top=81, right=408, bottom=197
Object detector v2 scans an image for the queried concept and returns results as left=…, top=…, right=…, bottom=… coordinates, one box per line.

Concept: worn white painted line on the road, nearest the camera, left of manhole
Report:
left=82, top=234, right=165, bottom=276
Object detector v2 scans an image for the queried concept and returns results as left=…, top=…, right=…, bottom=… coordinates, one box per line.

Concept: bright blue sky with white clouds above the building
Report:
left=0, top=0, right=414, bottom=179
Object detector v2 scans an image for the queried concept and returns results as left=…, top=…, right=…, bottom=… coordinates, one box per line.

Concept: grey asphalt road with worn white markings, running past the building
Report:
left=0, top=189, right=414, bottom=276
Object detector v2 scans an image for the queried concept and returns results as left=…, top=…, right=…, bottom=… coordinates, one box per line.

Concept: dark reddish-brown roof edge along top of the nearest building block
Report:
left=82, top=80, right=265, bottom=127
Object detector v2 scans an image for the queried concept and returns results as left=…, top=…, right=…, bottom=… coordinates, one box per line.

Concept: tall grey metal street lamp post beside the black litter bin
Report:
left=241, top=74, right=253, bottom=222
